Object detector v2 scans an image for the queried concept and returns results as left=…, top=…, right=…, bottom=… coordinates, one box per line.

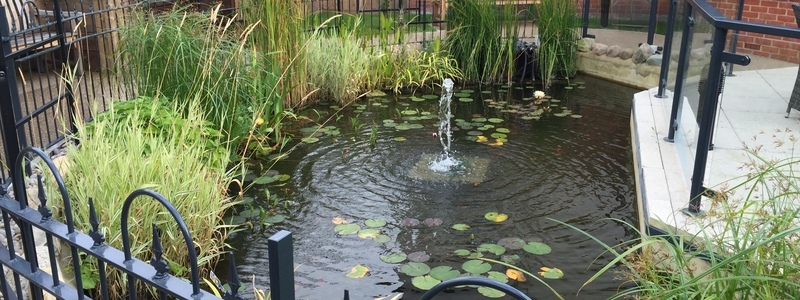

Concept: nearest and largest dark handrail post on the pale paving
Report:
left=683, top=27, right=728, bottom=215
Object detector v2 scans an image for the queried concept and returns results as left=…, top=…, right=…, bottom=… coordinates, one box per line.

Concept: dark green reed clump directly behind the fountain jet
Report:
left=444, top=0, right=518, bottom=82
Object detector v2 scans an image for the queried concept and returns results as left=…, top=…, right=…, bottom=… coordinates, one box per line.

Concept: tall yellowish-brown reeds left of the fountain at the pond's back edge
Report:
left=241, top=0, right=309, bottom=107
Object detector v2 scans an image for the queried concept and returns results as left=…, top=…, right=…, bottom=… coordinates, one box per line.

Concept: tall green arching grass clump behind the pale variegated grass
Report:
left=120, top=5, right=266, bottom=144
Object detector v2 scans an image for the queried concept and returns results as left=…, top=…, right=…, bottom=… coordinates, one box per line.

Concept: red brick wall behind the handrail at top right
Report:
left=709, top=0, right=800, bottom=63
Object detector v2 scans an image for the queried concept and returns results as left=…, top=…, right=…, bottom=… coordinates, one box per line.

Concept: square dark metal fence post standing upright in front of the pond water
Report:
left=267, top=230, right=294, bottom=300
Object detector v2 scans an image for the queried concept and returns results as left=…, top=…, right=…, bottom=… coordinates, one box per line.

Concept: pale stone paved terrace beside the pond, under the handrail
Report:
left=631, top=65, right=800, bottom=234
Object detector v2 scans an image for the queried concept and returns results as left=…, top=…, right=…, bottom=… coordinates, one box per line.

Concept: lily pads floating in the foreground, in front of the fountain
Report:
left=332, top=212, right=563, bottom=298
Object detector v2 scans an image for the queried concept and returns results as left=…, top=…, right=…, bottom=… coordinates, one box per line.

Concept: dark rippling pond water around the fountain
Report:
left=228, top=76, right=637, bottom=299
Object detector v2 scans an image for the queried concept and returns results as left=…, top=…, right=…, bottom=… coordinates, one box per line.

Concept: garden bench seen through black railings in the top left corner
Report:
left=0, top=0, right=83, bottom=74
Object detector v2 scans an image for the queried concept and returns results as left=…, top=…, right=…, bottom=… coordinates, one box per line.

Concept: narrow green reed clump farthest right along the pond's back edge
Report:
left=536, top=0, right=580, bottom=87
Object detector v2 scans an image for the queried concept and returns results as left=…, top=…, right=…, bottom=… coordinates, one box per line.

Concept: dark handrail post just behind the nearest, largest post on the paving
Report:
left=664, top=4, right=694, bottom=142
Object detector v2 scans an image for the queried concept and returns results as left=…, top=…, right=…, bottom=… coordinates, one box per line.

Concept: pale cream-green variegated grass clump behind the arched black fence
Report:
left=48, top=100, right=232, bottom=299
